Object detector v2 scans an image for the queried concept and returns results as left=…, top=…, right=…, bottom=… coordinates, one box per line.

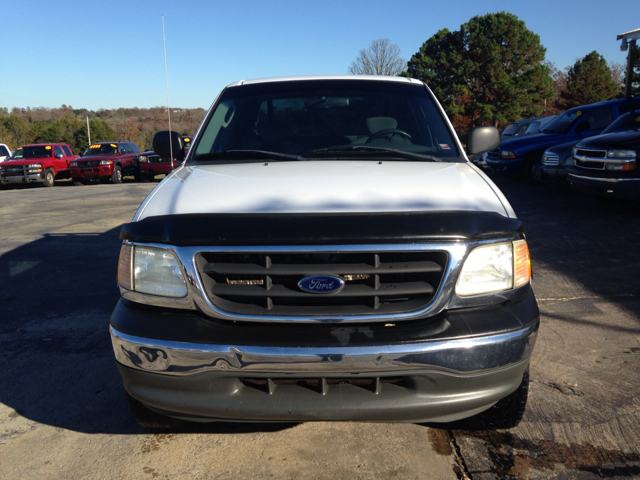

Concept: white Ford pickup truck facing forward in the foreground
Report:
left=110, top=76, right=539, bottom=428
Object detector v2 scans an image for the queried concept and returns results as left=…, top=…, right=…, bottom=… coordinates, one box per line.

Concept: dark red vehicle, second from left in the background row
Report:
left=70, top=142, right=140, bottom=185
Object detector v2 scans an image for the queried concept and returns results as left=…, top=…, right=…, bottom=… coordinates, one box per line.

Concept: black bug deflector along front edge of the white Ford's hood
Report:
left=120, top=211, right=525, bottom=246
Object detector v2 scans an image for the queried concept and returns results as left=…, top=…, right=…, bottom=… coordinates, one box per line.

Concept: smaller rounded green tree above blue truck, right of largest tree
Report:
left=560, top=50, right=620, bottom=108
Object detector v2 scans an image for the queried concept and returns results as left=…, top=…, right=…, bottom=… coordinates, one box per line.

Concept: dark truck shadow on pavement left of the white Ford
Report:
left=0, top=228, right=291, bottom=438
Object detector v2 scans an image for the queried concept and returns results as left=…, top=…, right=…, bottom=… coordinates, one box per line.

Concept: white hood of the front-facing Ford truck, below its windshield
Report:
left=134, top=161, right=515, bottom=220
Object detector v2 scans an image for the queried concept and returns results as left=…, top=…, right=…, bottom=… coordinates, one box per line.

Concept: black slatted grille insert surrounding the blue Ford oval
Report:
left=197, top=252, right=447, bottom=316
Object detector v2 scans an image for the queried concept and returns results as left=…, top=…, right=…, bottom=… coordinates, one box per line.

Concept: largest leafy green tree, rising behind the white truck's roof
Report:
left=403, top=12, right=553, bottom=130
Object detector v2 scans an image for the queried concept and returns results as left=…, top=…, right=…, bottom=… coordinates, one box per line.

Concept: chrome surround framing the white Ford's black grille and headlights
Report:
left=119, top=234, right=529, bottom=323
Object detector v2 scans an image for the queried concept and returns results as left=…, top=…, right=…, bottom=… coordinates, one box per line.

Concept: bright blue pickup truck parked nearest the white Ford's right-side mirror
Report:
left=485, top=97, right=640, bottom=177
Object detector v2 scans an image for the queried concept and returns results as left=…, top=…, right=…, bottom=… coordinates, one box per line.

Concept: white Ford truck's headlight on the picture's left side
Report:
left=118, top=245, right=187, bottom=297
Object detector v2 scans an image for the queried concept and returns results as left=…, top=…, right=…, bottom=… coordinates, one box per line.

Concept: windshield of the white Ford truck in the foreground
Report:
left=194, top=80, right=459, bottom=161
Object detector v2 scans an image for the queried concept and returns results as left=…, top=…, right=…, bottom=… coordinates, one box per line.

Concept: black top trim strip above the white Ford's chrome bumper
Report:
left=111, top=288, right=539, bottom=347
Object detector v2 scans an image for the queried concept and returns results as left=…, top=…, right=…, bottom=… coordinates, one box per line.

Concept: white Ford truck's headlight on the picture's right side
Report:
left=456, top=240, right=531, bottom=296
